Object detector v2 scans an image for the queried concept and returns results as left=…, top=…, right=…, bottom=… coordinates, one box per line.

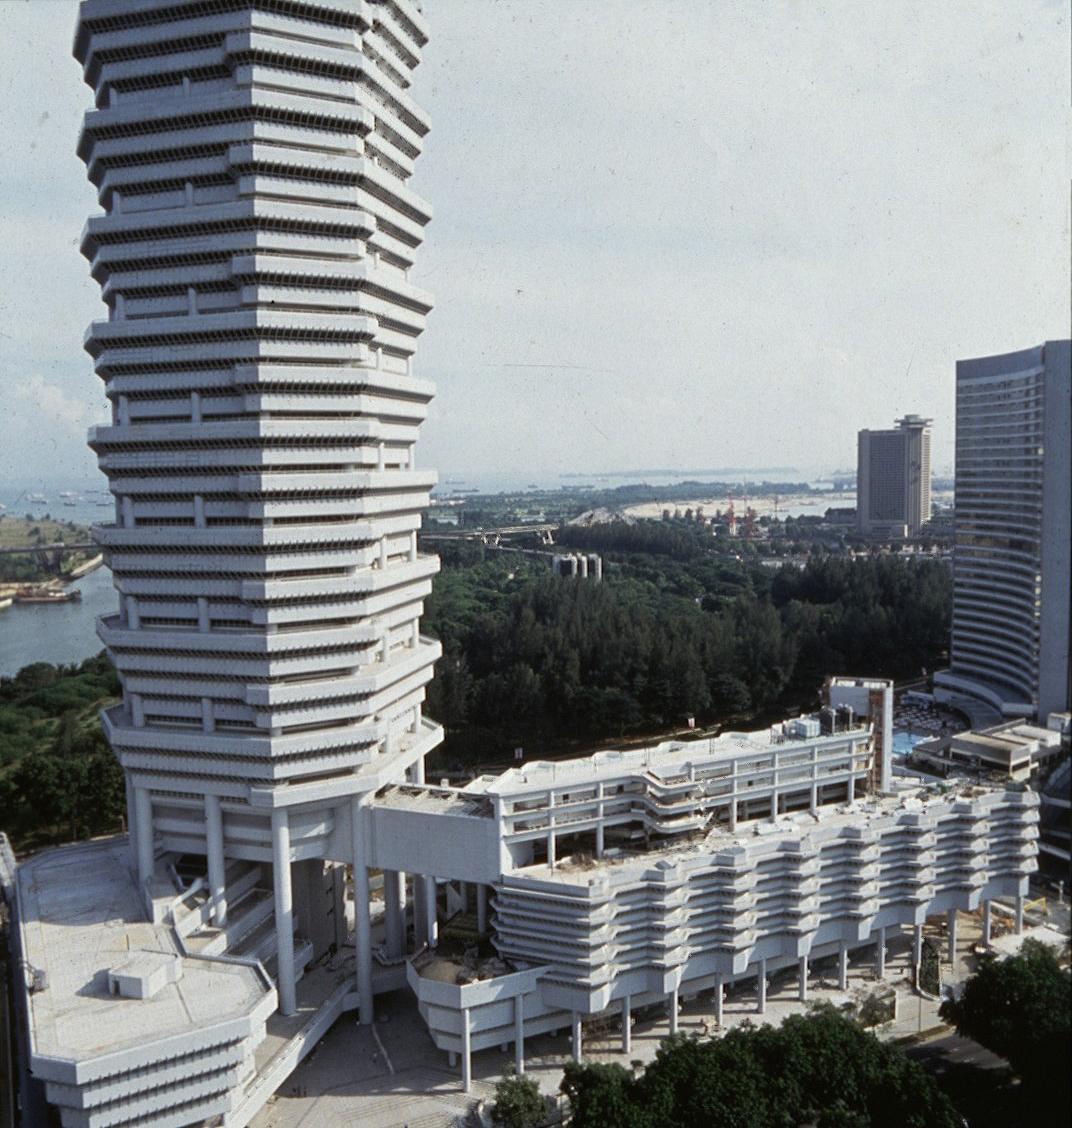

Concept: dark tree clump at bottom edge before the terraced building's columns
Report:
left=562, top=1008, right=958, bottom=1128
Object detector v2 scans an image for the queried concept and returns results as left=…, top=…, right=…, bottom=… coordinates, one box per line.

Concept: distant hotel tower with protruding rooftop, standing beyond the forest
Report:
left=856, top=415, right=931, bottom=537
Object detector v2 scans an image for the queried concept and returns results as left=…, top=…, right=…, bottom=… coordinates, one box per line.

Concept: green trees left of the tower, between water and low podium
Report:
left=0, top=653, right=124, bottom=844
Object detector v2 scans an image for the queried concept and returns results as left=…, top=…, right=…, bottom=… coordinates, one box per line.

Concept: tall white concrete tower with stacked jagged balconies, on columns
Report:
left=74, top=0, right=440, bottom=1012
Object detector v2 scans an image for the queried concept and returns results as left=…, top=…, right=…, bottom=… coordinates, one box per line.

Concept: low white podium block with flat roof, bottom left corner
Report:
left=16, top=839, right=276, bottom=1128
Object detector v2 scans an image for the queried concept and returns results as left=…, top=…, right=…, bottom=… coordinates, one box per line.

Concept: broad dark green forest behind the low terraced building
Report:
left=424, top=539, right=950, bottom=759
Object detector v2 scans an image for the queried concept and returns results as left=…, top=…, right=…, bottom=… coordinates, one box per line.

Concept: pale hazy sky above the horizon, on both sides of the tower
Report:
left=0, top=0, right=1070, bottom=484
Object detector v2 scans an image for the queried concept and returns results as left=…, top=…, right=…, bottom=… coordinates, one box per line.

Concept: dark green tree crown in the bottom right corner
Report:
left=940, top=940, right=1072, bottom=1125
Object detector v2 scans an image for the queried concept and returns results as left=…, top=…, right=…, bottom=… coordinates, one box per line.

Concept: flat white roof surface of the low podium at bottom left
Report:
left=18, top=839, right=269, bottom=1060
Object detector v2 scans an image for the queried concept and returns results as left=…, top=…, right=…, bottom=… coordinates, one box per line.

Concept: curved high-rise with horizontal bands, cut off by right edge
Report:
left=935, top=341, right=1072, bottom=720
